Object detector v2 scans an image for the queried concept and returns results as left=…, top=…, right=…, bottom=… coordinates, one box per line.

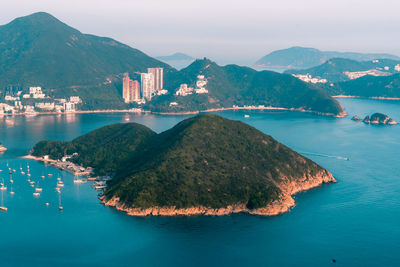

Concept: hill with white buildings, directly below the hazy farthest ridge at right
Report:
left=285, top=58, right=400, bottom=83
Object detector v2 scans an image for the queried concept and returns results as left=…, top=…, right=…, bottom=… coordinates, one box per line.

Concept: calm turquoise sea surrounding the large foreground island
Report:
left=0, top=99, right=400, bottom=266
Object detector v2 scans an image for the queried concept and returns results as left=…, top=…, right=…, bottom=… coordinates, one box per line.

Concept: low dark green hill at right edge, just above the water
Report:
left=330, top=74, right=400, bottom=98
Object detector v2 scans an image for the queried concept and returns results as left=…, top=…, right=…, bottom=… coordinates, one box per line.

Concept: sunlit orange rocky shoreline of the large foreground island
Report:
left=100, top=170, right=337, bottom=217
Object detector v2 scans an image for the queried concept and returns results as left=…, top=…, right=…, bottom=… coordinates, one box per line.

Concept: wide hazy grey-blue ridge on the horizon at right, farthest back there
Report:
left=255, top=46, right=400, bottom=69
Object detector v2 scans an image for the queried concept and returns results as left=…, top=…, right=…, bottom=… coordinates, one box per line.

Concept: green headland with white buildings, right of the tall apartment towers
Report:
left=152, top=59, right=343, bottom=115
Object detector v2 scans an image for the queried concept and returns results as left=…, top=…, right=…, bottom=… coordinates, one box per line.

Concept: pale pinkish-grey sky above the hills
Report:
left=0, top=0, right=400, bottom=64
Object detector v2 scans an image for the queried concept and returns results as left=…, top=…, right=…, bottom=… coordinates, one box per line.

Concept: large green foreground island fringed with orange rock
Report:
left=32, top=114, right=336, bottom=216
